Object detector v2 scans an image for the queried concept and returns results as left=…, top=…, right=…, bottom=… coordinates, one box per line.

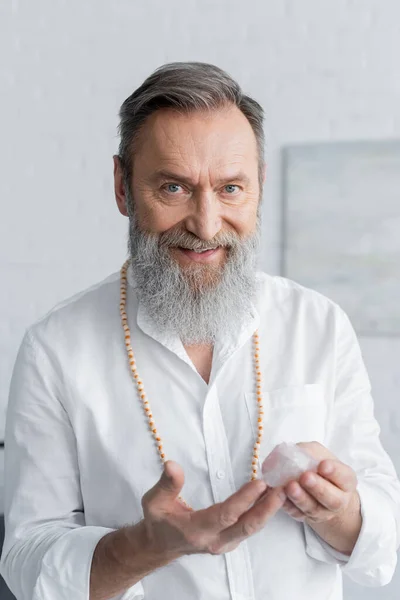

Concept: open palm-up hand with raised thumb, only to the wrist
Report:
left=142, top=461, right=286, bottom=558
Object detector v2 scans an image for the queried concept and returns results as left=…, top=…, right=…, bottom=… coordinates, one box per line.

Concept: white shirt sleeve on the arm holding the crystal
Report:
left=303, top=307, right=400, bottom=587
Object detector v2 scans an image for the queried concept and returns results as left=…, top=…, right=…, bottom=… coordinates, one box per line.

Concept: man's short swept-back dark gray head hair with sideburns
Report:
left=118, top=62, right=265, bottom=189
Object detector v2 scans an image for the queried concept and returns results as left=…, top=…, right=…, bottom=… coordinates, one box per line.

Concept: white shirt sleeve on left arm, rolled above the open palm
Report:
left=0, top=331, right=144, bottom=600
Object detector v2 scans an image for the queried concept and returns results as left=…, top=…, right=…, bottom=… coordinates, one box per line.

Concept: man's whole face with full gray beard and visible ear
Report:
left=114, top=108, right=266, bottom=344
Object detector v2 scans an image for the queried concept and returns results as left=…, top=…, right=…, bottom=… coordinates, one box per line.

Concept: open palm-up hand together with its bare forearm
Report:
left=89, top=461, right=285, bottom=600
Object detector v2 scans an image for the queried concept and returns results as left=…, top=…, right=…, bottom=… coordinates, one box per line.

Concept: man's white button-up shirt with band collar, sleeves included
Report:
left=1, top=264, right=400, bottom=600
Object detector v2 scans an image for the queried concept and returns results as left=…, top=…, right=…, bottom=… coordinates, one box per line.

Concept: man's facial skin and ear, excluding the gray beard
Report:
left=115, top=106, right=260, bottom=273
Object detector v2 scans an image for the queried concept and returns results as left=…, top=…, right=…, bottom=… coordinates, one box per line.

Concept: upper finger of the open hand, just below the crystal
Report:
left=198, top=479, right=266, bottom=533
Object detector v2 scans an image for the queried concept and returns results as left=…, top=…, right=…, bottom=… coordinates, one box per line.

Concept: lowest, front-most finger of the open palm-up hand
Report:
left=218, top=488, right=286, bottom=547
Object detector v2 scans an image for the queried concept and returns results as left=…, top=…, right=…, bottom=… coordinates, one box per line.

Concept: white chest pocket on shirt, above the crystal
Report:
left=245, top=383, right=326, bottom=466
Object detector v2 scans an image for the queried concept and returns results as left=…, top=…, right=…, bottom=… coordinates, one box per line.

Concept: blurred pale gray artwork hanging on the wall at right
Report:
left=281, top=141, right=400, bottom=336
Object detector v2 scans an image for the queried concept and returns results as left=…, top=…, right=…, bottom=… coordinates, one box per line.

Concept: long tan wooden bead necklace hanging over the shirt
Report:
left=119, top=259, right=264, bottom=510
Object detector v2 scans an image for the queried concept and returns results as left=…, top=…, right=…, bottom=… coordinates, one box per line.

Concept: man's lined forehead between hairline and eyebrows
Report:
left=134, top=106, right=257, bottom=167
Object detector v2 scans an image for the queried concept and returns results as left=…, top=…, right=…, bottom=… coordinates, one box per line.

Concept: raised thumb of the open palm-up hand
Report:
left=142, top=460, right=185, bottom=510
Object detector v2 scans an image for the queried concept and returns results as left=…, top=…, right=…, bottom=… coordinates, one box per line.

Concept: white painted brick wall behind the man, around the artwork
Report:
left=0, top=0, right=400, bottom=600
